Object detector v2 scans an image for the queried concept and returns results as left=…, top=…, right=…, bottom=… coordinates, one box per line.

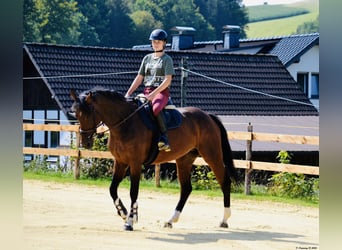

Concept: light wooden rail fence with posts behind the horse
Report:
left=23, top=123, right=319, bottom=193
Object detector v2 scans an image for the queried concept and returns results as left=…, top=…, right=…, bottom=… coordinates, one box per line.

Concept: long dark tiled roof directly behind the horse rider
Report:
left=24, top=43, right=318, bottom=116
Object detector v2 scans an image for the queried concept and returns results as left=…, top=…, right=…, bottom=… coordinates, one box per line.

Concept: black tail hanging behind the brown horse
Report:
left=210, top=114, right=238, bottom=182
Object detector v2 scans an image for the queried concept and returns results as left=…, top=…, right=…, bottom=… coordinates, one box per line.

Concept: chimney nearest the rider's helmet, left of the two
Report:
left=171, top=26, right=196, bottom=50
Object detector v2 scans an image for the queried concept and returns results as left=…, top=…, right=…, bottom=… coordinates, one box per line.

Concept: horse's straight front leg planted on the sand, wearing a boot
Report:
left=124, top=164, right=142, bottom=231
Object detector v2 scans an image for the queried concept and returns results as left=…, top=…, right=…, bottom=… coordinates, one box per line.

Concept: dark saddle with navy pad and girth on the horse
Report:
left=134, top=94, right=183, bottom=166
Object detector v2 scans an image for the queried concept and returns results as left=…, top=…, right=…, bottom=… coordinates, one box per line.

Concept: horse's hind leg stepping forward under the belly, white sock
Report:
left=164, top=152, right=198, bottom=228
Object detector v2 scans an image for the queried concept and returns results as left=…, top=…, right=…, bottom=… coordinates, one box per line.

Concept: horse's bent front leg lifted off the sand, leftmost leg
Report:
left=109, top=162, right=128, bottom=223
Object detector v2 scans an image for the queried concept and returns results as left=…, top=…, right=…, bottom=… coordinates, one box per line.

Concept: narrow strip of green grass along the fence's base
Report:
left=23, top=172, right=318, bottom=207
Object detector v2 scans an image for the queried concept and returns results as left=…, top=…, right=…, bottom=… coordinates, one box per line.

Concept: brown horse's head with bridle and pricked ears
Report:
left=70, top=90, right=101, bottom=149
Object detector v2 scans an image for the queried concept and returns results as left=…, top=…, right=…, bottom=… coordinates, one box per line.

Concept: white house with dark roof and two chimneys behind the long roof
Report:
left=134, top=25, right=319, bottom=109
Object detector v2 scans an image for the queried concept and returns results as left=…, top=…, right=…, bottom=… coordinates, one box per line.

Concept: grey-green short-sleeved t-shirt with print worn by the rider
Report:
left=139, top=53, right=175, bottom=87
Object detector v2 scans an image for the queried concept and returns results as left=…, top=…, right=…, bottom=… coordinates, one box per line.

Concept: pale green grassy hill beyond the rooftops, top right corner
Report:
left=246, top=0, right=319, bottom=38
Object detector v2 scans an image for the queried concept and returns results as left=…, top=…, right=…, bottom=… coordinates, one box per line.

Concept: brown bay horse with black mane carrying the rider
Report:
left=70, top=88, right=237, bottom=231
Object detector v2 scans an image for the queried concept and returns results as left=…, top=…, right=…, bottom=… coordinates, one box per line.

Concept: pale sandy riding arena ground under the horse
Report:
left=23, top=180, right=319, bottom=250
